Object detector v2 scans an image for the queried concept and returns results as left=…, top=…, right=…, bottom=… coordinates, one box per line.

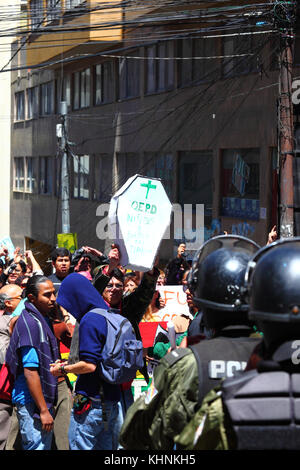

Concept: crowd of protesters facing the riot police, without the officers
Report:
left=0, top=239, right=195, bottom=450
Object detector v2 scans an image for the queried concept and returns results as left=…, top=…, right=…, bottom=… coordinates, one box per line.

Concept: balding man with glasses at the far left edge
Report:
left=0, top=284, right=22, bottom=450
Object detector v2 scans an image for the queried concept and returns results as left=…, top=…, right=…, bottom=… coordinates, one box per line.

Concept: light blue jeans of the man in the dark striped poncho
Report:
left=16, top=403, right=53, bottom=450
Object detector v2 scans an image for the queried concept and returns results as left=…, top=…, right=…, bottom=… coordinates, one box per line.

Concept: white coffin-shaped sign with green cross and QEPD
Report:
left=108, top=175, right=172, bottom=271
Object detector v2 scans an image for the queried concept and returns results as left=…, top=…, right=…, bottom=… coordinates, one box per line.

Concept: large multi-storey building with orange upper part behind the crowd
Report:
left=11, top=0, right=300, bottom=260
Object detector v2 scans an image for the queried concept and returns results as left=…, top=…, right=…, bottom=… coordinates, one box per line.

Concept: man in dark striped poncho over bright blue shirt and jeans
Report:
left=6, top=276, right=59, bottom=450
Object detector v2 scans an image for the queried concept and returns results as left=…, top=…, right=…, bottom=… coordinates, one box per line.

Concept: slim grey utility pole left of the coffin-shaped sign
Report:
left=60, top=101, right=70, bottom=233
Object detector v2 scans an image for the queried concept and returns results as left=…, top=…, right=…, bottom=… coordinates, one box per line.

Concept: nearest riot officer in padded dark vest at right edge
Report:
left=179, top=238, right=300, bottom=450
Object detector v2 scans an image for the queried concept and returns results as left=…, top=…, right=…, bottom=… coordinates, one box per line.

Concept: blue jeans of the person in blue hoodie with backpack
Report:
left=69, top=401, right=119, bottom=450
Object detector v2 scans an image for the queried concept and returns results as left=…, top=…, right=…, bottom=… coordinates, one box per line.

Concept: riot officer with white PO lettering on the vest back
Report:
left=120, top=235, right=261, bottom=450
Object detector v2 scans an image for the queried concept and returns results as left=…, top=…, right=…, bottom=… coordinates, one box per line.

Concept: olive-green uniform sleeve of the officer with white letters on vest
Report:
left=120, top=348, right=198, bottom=450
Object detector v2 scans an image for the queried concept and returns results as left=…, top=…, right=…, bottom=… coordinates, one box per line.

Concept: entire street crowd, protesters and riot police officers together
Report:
left=0, top=227, right=300, bottom=450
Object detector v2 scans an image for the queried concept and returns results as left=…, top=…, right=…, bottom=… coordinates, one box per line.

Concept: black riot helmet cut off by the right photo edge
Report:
left=246, top=241, right=300, bottom=342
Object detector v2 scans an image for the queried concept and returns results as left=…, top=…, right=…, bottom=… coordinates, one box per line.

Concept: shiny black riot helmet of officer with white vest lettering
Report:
left=188, top=235, right=260, bottom=328
